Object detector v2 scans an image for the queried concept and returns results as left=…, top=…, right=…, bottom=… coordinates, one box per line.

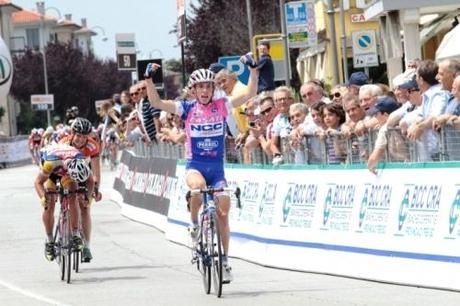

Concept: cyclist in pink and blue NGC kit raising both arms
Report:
left=145, top=59, right=258, bottom=283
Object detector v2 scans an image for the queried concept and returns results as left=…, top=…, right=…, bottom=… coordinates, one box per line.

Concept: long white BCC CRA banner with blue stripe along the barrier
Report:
left=166, top=164, right=460, bottom=290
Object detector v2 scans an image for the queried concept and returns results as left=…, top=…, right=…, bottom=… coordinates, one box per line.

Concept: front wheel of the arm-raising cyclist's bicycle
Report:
left=210, top=213, right=223, bottom=297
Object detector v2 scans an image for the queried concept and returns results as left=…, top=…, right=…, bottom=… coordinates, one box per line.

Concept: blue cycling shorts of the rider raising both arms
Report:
left=185, top=160, right=227, bottom=188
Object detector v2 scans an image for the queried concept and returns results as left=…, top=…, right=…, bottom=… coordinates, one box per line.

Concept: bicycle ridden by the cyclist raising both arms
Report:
left=186, top=187, right=241, bottom=297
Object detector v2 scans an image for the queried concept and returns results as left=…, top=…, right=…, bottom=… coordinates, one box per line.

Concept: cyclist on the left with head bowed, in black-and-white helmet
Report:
left=35, top=144, right=94, bottom=261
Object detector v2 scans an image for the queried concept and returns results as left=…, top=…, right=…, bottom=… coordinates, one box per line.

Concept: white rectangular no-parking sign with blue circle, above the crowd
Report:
left=351, top=30, right=379, bottom=68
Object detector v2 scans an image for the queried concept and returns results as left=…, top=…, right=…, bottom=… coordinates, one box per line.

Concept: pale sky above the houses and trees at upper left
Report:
left=11, top=0, right=196, bottom=60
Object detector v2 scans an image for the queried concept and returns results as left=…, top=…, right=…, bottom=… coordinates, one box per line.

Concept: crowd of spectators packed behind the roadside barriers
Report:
left=99, top=44, right=460, bottom=172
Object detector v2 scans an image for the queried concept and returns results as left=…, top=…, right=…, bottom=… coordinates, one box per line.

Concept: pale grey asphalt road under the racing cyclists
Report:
left=0, top=166, right=460, bottom=306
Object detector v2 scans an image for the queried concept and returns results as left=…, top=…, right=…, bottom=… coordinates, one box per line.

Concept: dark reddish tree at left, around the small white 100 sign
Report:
left=10, top=44, right=130, bottom=132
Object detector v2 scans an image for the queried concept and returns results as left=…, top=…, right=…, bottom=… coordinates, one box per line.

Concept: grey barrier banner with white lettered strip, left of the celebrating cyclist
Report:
left=114, top=150, right=177, bottom=216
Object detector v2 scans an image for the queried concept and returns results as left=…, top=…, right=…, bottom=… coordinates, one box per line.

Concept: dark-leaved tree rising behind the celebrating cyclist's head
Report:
left=185, top=0, right=299, bottom=87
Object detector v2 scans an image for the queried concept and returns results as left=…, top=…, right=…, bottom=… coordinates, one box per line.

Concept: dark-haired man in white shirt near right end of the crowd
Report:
left=407, top=60, right=449, bottom=161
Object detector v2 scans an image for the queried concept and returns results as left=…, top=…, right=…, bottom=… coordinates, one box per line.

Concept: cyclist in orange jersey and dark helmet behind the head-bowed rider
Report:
left=59, top=117, right=102, bottom=262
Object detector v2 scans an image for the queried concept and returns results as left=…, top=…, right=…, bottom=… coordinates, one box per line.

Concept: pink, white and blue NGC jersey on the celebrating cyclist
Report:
left=176, top=97, right=232, bottom=163
